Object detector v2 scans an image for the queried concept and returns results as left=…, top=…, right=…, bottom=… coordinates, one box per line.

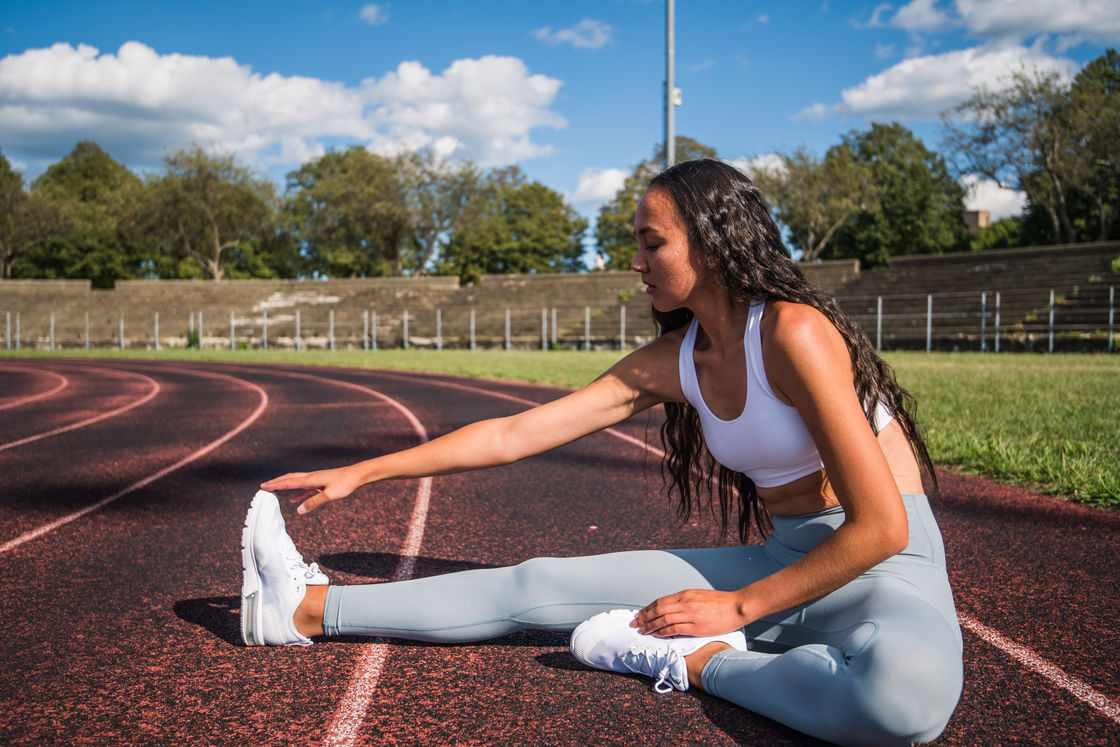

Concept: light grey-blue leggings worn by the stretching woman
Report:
left=324, top=495, right=962, bottom=745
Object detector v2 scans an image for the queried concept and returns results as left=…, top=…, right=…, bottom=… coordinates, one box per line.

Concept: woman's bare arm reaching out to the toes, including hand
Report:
left=261, top=337, right=680, bottom=513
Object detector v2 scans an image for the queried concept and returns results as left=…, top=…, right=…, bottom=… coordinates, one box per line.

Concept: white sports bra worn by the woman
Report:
left=678, top=299, right=893, bottom=487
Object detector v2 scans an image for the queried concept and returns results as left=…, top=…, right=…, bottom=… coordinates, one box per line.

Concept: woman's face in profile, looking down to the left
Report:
left=631, top=187, right=704, bottom=311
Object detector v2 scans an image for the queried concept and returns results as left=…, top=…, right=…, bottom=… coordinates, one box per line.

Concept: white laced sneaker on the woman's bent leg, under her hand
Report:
left=571, top=609, right=747, bottom=692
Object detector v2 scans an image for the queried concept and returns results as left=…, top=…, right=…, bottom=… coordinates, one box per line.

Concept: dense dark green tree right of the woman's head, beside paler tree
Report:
left=822, top=122, right=968, bottom=267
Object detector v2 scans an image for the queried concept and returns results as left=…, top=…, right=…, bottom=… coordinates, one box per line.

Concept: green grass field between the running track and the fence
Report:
left=4, top=349, right=1120, bottom=508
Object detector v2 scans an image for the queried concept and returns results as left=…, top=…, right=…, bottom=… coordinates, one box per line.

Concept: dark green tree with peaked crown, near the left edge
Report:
left=13, top=141, right=146, bottom=288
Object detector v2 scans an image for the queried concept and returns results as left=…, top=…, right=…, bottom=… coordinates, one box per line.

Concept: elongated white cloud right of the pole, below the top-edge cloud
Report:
left=796, top=44, right=1076, bottom=121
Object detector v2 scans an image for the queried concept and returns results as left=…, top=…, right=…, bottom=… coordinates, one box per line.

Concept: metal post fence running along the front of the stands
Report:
left=0, top=284, right=1116, bottom=353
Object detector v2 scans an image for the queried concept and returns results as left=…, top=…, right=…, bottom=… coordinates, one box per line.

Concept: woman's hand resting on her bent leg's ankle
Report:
left=631, top=589, right=750, bottom=638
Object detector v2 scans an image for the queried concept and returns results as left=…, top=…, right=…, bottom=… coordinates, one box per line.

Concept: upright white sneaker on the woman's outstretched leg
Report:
left=241, top=491, right=330, bottom=646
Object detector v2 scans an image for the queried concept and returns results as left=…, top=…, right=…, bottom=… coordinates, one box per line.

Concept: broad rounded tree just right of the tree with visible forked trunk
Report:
left=284, top=147, right=410, bottom=278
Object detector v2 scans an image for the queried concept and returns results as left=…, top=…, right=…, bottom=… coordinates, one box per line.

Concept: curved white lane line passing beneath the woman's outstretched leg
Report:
left=255, top=370, right=431, bottom=747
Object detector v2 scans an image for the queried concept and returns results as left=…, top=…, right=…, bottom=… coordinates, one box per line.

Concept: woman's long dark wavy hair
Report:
left=650, top=159, right=936, bottom=542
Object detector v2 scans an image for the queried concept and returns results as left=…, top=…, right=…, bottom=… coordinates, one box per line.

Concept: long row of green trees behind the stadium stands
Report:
left=0, top=49, right=1120, bottom=287
